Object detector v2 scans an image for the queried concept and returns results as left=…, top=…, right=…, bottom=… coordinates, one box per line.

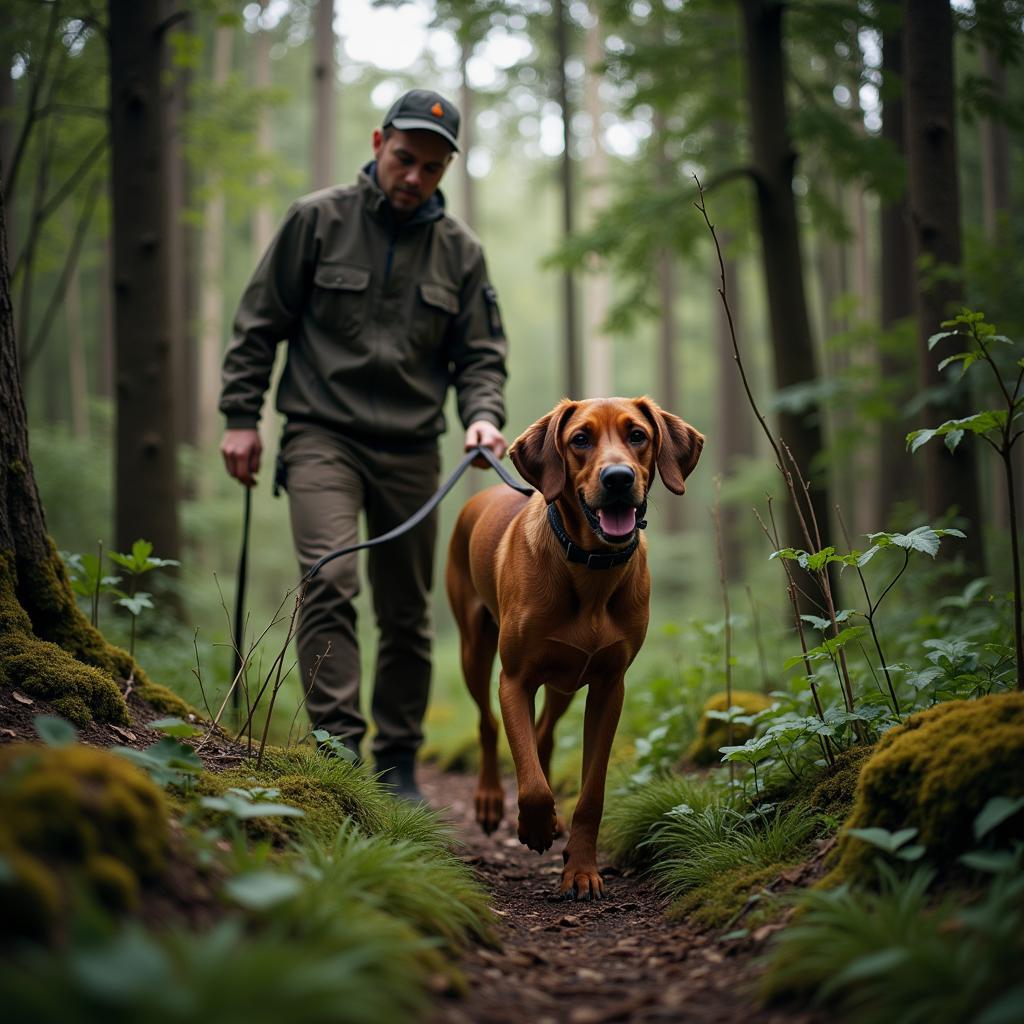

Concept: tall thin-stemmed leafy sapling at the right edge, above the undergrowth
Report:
left=906, top=309, right=1024, bottom=690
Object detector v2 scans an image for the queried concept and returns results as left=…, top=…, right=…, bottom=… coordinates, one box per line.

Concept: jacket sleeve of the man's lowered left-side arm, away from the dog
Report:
left=219, top=204, right=315, bottom=429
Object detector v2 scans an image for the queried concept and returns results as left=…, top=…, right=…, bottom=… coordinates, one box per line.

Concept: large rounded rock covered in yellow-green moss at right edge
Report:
left=823, top=693, right=1024, bottom=885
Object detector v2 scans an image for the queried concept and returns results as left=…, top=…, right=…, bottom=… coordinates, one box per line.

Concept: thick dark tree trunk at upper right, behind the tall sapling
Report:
left=903, top=0, right=984, bottom=573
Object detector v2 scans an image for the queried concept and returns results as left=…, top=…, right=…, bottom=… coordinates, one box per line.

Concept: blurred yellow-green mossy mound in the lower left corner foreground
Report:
left=0, top=743, right=169, bottom=938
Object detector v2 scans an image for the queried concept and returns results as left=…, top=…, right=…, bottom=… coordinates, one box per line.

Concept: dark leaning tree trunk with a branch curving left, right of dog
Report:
left=740, top=0, right=829, bottom=548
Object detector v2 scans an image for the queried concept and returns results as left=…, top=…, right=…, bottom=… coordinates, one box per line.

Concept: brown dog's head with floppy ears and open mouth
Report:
left=509, top=397, right=703, bottom=544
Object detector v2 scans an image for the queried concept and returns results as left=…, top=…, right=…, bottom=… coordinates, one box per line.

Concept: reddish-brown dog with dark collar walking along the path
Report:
left=446, top=398, right=703, bottom=898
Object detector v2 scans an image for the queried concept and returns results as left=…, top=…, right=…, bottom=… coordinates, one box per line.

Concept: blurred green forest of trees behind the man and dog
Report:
left=0, top=0, right=1024, bottom=757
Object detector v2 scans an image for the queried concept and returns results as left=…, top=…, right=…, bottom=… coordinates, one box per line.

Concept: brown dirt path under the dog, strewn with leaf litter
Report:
left=420, top=766, right=816, bottom=1024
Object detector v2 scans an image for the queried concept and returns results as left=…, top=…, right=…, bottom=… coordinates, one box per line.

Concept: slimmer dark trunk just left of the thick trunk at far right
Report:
left=876, top=14, right=918, bottom=529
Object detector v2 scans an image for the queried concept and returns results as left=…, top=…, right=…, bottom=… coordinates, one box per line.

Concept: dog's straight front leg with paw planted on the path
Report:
left=559, top=678, right=625, bottom=899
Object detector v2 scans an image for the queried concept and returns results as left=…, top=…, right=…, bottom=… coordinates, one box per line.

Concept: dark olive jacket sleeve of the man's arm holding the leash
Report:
left=450, top=248, right=508, bottom=428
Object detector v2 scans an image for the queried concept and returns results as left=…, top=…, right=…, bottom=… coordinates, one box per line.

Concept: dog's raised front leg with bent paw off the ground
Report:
left=498, top=672, right=556, bottom=853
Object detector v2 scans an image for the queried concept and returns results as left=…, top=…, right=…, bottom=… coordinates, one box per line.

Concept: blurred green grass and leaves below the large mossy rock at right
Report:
left=762, top=797, right=1024, bottom=1024
